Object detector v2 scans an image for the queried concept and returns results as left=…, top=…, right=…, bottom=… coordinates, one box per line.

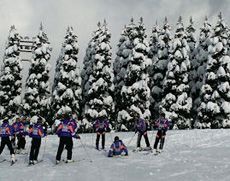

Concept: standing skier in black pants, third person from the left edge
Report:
left=29, top=117, right=46, bottom=165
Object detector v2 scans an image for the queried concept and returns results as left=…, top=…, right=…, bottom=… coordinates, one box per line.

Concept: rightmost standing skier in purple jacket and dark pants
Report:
left=153, top=112, right=169, bottom=153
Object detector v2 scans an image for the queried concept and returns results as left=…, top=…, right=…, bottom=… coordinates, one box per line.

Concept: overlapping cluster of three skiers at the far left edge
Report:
left=0, top=116, right=47, bottom=164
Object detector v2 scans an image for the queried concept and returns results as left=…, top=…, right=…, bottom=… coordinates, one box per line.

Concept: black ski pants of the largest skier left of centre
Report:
left=56, top=136, right=73, bottom=161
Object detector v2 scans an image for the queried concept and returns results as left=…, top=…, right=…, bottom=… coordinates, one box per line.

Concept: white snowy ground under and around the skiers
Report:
left=0, top=129, right=230, bottom=181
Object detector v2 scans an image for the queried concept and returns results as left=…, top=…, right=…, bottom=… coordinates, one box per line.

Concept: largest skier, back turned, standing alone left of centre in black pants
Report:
left=56, top=113, right=80, bottom=164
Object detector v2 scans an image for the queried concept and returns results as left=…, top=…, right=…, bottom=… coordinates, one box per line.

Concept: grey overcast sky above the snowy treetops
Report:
left=0, top=0, right=230, bottom=82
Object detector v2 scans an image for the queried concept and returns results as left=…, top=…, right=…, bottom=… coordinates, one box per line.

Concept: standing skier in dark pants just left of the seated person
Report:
left=93, top=115, right=110, bottom=150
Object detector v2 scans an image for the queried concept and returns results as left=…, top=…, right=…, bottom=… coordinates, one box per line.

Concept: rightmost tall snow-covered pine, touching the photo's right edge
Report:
left=198, top=13, right=230, bottom=128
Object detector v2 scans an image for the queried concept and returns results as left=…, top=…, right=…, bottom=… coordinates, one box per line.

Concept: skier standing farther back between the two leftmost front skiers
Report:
left=12, top=116, right=26, bottom=153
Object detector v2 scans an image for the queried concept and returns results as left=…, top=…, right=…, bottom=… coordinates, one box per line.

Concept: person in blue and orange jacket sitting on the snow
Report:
left=108, top=136, right=128, bottom=157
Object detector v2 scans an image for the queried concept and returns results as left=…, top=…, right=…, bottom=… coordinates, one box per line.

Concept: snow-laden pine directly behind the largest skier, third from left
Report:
left=52, top=27, right=81, bottom=116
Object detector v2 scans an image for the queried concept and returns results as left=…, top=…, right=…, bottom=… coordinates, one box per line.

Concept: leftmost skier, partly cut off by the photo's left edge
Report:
left=0, top=118, right=15, bottom=164
